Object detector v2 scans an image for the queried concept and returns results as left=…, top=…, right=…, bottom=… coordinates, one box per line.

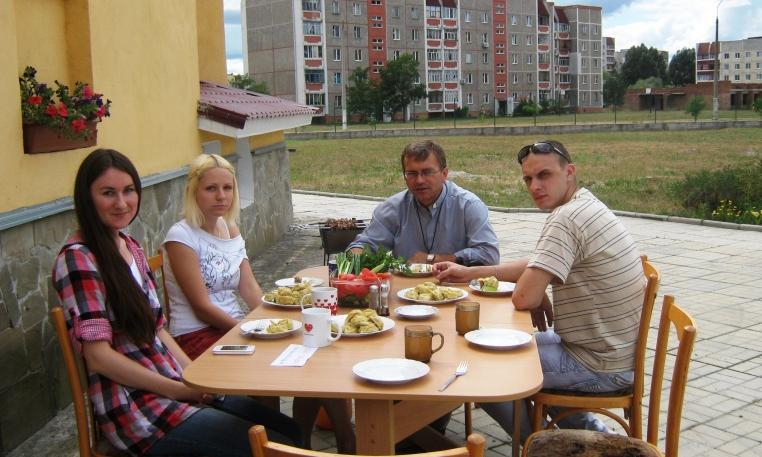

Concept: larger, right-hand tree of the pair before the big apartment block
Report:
left=379, top=53, right=426, bottom=116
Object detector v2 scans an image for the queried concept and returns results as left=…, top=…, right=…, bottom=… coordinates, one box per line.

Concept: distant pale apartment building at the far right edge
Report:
left=696, top=37, right=762, bottom=84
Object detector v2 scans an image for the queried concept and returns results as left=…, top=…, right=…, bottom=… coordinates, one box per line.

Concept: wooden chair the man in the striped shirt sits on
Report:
left=531, top=256, right=661, bottom=438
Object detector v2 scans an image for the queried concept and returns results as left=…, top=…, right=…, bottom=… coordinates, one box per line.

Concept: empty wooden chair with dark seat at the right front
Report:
left=523, top=295, right=696, bottom=457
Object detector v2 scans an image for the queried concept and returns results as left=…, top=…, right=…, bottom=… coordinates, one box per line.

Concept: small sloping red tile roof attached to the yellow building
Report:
left=198, top=81, right=316, bottom=129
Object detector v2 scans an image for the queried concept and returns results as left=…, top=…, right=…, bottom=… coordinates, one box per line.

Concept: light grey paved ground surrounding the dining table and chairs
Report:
left=9, top=193, right=762, bottom=457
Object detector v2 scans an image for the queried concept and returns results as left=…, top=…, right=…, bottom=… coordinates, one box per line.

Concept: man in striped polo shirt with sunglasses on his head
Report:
left=434, top=140, right=646, bottom=441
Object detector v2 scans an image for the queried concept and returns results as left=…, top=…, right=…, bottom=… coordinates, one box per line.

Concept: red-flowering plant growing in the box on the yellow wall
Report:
left=19, top=66, right=111, bottom=138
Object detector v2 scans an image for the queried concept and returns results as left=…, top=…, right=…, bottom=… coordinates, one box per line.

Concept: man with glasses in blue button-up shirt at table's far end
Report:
left=349, top=140, right=500, bottom=265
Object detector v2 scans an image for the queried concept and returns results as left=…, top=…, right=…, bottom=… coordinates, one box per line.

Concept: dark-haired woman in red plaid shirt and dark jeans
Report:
left=53, top=149, right=301, bottom=457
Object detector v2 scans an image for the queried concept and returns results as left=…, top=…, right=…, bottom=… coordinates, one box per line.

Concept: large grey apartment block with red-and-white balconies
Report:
left=244, top=0, right=603, bottom=116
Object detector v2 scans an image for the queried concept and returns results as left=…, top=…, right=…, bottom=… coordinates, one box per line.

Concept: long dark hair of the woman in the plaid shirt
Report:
left=74, top=149, right=156, bottom=345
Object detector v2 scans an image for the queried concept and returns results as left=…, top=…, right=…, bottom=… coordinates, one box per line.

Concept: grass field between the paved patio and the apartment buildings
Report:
left=288, top=128, right=762, bottom=216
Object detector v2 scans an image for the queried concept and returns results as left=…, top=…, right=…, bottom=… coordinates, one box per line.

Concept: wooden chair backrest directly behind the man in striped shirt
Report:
left=632, top=255, right=661, bottom=430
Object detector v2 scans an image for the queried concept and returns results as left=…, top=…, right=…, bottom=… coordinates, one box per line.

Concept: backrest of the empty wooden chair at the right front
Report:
left=648, top=295, right=696, bottom=457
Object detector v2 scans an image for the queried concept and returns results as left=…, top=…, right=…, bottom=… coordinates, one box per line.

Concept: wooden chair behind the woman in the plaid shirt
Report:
left=50, top=306, right=127, bottom=457
